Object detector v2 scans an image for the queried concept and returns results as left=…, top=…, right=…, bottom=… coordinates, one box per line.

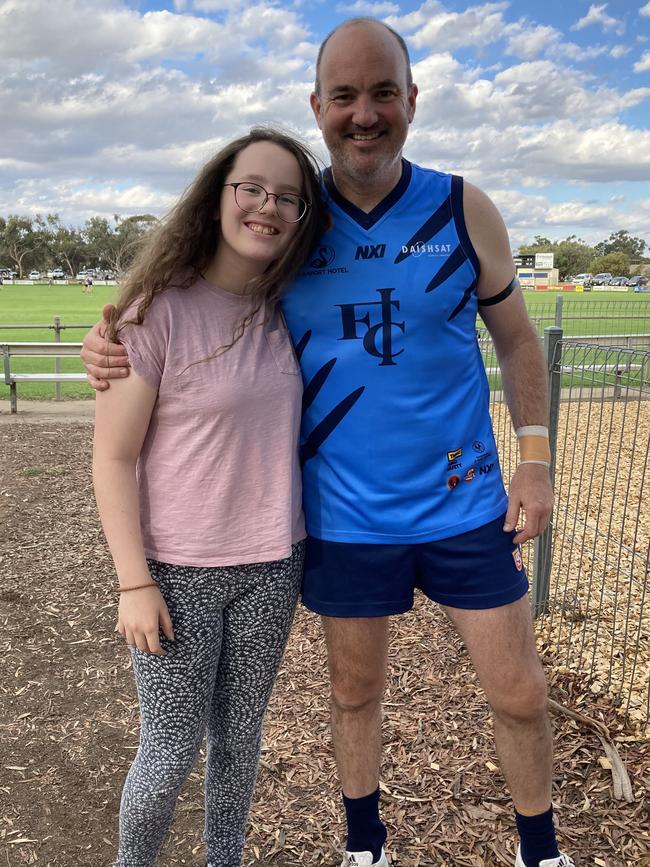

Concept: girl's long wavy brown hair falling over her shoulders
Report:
left=107, top=127, right=327, bottom=344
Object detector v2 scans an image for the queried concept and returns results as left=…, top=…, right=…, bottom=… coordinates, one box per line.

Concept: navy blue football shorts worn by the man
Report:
left=302, top=515, right=528, bottom=617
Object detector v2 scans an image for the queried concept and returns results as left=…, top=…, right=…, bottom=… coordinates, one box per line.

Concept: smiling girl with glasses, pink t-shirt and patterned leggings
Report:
left=93, top=129, right=323, bottom=867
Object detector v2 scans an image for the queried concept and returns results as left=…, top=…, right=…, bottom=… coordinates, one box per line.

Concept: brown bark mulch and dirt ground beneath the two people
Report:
left=0, top=419, right=650, bottom=867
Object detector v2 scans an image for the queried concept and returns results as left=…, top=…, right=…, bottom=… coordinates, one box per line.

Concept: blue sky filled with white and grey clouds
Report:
left=0, top=0, right=650, bottom=247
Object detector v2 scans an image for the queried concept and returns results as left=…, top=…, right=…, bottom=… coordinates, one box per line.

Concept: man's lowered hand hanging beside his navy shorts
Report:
left=503, top=464, right=553, bottom=545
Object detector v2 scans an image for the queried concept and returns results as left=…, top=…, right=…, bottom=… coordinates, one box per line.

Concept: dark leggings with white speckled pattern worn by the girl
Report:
left=117, top=542, right=304, bottom=867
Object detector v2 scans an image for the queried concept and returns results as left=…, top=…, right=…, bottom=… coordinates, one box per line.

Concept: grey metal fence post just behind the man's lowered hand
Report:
left=532, top=326, right=563, bottom=617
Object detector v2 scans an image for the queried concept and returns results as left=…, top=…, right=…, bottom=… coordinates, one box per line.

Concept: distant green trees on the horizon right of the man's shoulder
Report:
left=517, top=229, right=646, bottom=280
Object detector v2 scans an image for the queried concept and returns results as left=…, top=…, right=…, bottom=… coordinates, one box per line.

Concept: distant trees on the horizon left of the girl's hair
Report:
left=0, top=214, right=157, bottom=277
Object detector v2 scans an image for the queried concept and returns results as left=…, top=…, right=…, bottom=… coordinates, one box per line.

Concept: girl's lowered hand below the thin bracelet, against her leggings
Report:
left=116, top=584, right=174, bottom=656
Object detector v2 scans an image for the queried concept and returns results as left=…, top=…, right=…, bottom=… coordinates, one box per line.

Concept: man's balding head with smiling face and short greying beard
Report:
left=311, top=22, right=417, bottom=193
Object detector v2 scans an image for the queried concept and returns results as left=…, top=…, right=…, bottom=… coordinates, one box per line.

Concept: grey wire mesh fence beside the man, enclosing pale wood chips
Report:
left=482, top=328, right=650, bottom=728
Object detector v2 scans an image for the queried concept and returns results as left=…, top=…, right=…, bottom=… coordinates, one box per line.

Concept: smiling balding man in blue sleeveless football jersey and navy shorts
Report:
left=82, top=19, right=573, bottom=867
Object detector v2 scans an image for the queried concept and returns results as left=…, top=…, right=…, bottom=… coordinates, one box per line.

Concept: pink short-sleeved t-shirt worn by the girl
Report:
left=120, top=279, right=305, bottom=566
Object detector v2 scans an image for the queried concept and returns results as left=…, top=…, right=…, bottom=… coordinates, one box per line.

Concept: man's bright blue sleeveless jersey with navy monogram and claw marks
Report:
left=283, top=161, right=507, bottom=544
